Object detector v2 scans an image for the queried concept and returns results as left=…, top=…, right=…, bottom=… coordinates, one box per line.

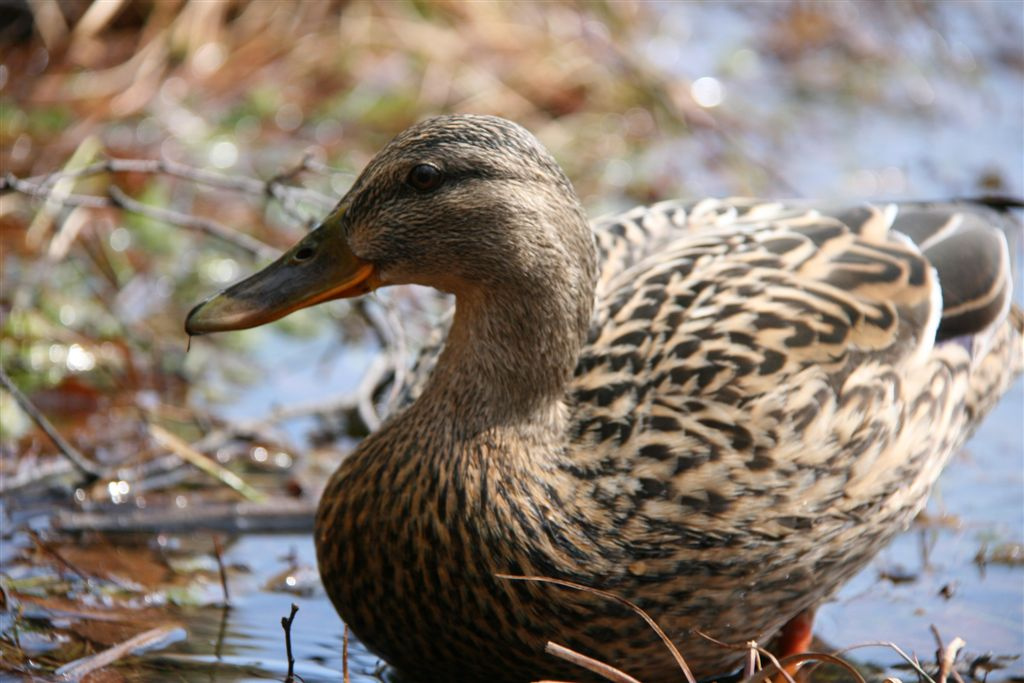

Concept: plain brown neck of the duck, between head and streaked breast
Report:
left=418, top=270, right=593, bottom=435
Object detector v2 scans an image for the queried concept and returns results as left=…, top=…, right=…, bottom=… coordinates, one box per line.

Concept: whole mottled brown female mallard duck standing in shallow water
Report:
left=185, top=116, right=1024, bottom=683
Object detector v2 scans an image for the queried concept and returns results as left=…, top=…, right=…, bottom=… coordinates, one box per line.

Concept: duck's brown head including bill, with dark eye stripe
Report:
left=185, top=116, right=596, bottom=335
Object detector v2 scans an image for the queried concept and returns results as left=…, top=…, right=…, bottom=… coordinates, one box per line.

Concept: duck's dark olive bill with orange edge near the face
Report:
left=185, top=212, right=380, bottom=335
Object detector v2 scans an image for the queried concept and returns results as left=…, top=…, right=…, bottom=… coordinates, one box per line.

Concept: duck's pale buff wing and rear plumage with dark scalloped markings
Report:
left=571, top=200, right=1024, bottom=533
